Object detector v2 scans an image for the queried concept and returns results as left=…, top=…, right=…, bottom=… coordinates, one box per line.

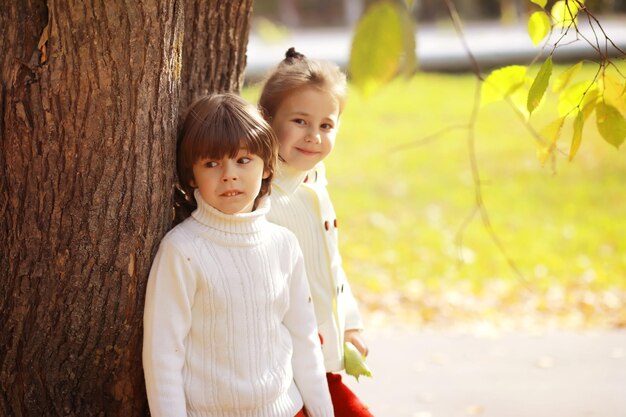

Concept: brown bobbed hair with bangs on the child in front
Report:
left=177, top=93, right=278, bottom=210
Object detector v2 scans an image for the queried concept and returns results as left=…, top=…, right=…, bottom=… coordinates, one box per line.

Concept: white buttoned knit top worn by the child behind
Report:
left=267, top=162, right=363, bottom=372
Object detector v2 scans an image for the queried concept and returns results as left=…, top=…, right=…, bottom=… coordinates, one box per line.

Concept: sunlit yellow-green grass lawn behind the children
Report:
left=243, top=68, right=626, bottom=325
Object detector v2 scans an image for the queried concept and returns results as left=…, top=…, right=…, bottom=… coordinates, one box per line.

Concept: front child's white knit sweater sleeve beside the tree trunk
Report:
left=143, top=239, right=196, bottom=417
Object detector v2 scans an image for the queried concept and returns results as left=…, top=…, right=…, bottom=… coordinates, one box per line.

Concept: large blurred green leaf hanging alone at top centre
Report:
left=349, top=1, right=415, bottom=95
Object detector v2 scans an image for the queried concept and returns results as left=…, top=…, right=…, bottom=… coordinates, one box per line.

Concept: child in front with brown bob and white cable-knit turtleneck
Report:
left=143, top=94, right=333, bottom=417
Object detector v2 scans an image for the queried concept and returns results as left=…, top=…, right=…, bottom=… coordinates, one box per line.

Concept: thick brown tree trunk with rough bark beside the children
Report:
left=0, top=0, right=251, bottom=417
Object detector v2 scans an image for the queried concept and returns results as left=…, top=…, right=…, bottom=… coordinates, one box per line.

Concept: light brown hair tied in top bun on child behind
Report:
left=259, top=48, right=347, bottom=121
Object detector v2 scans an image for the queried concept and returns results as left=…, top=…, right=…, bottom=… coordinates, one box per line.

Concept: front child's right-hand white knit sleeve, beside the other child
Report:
left=283, top=237, right=334, bottom=417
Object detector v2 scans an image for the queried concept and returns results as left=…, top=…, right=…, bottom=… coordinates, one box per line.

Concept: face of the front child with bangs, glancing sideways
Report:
left=191, top=149, right=269, bottom=214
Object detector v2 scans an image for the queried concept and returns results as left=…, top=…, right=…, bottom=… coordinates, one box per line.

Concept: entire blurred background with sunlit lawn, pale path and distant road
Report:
left=242, top=0, right=626, bottom=417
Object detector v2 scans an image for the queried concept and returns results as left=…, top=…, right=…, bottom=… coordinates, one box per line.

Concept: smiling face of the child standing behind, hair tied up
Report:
left=272, top=87, right=339, bottom=171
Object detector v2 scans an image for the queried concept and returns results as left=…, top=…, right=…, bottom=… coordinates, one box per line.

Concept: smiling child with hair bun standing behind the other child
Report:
left=259, top=48, right=371, bottom=416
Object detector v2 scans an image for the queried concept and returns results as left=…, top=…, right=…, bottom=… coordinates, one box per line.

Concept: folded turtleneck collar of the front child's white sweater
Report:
left=191, top=189, right=270, bottom=240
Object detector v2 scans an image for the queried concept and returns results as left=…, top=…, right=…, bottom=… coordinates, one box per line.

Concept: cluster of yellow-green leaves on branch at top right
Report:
left=481, top=0, right=626, bottom=163
